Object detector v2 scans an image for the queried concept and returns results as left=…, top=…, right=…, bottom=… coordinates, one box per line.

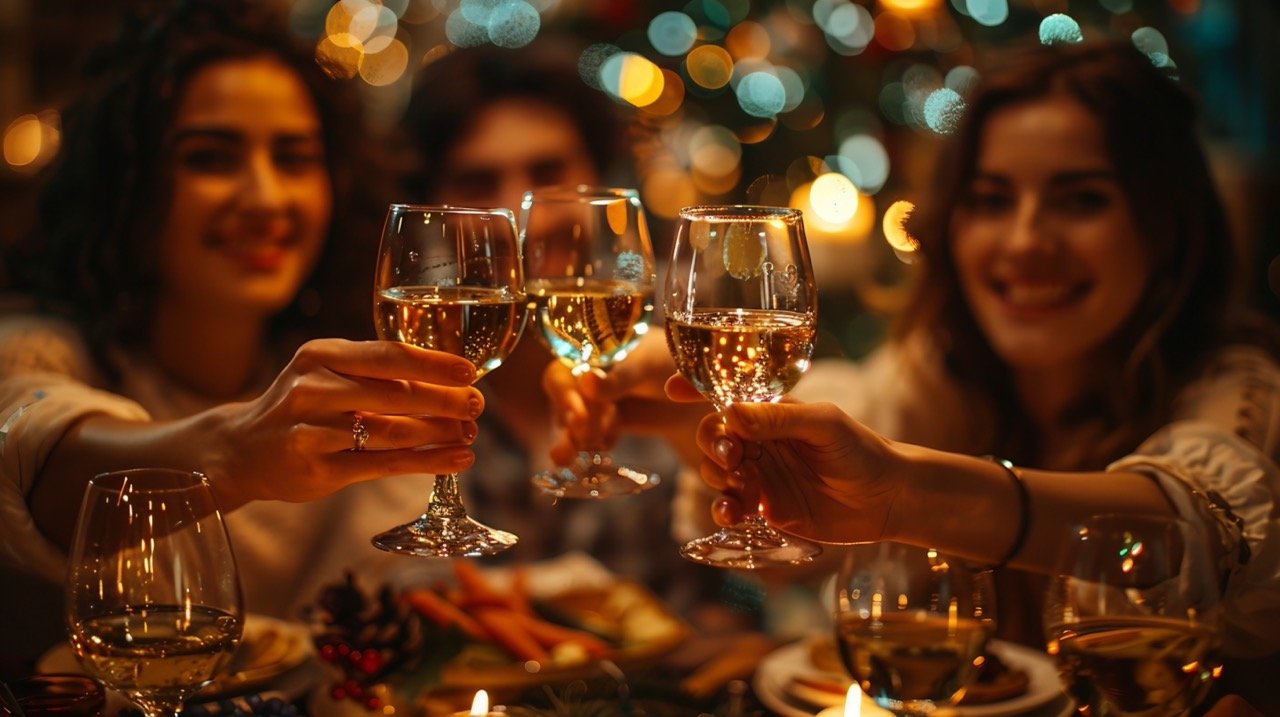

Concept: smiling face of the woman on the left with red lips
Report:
left=159, top=56, right=333, bottom=316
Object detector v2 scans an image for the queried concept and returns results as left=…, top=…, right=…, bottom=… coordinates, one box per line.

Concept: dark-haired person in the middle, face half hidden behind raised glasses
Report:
left=394, top=37, right=717, bottom=619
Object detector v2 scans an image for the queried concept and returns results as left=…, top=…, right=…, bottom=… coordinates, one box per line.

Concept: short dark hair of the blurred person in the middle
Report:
left=396, top=37, right=627, bottom=200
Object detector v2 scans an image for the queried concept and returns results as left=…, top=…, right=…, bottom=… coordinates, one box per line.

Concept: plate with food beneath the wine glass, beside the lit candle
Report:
left=754, top=635, right=1071, bottom=717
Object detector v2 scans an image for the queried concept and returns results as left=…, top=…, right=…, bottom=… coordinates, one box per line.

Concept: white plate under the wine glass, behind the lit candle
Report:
left=753, top=640, right=1073, bottom=717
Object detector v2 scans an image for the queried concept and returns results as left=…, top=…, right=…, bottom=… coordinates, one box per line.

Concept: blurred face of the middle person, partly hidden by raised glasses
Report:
left=430, top=97, right=599, bottom=215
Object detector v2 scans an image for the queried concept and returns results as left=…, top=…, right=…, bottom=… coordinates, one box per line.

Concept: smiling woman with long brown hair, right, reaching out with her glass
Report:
left=547, top=42, right=1280, bottom=713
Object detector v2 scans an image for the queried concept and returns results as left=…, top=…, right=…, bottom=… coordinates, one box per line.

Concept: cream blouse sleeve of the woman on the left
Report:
left=0, top=319, right=148, bottom=581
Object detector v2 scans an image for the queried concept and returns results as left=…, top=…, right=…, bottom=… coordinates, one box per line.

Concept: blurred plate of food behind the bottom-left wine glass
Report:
left=36, top=613, right=321, bottom=702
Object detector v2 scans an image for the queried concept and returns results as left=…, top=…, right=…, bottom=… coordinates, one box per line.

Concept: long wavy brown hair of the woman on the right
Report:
left=895, top=42, right=1264, bottom=469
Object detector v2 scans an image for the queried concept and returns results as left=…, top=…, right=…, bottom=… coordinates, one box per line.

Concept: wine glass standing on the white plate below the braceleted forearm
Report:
left=836, top=543, right=996, bottom=714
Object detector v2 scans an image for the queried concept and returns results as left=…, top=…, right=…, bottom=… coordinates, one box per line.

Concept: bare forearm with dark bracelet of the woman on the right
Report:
left=890, top=444, right=1174, bottom=572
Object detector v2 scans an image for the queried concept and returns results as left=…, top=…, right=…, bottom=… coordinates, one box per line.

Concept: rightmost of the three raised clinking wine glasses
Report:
left=664, top=206, right=822, bottom=568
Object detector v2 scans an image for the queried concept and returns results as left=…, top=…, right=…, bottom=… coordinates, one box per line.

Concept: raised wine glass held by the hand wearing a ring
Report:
left=374, top=204, right=526, bottom=556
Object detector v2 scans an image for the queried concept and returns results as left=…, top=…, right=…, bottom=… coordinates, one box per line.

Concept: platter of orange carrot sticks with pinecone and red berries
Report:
left=304, top=550, right=689, bottom=714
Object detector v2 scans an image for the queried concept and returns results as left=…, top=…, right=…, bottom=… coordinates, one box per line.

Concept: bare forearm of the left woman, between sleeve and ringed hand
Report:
left=28, top=411, right=244, bottom=549
